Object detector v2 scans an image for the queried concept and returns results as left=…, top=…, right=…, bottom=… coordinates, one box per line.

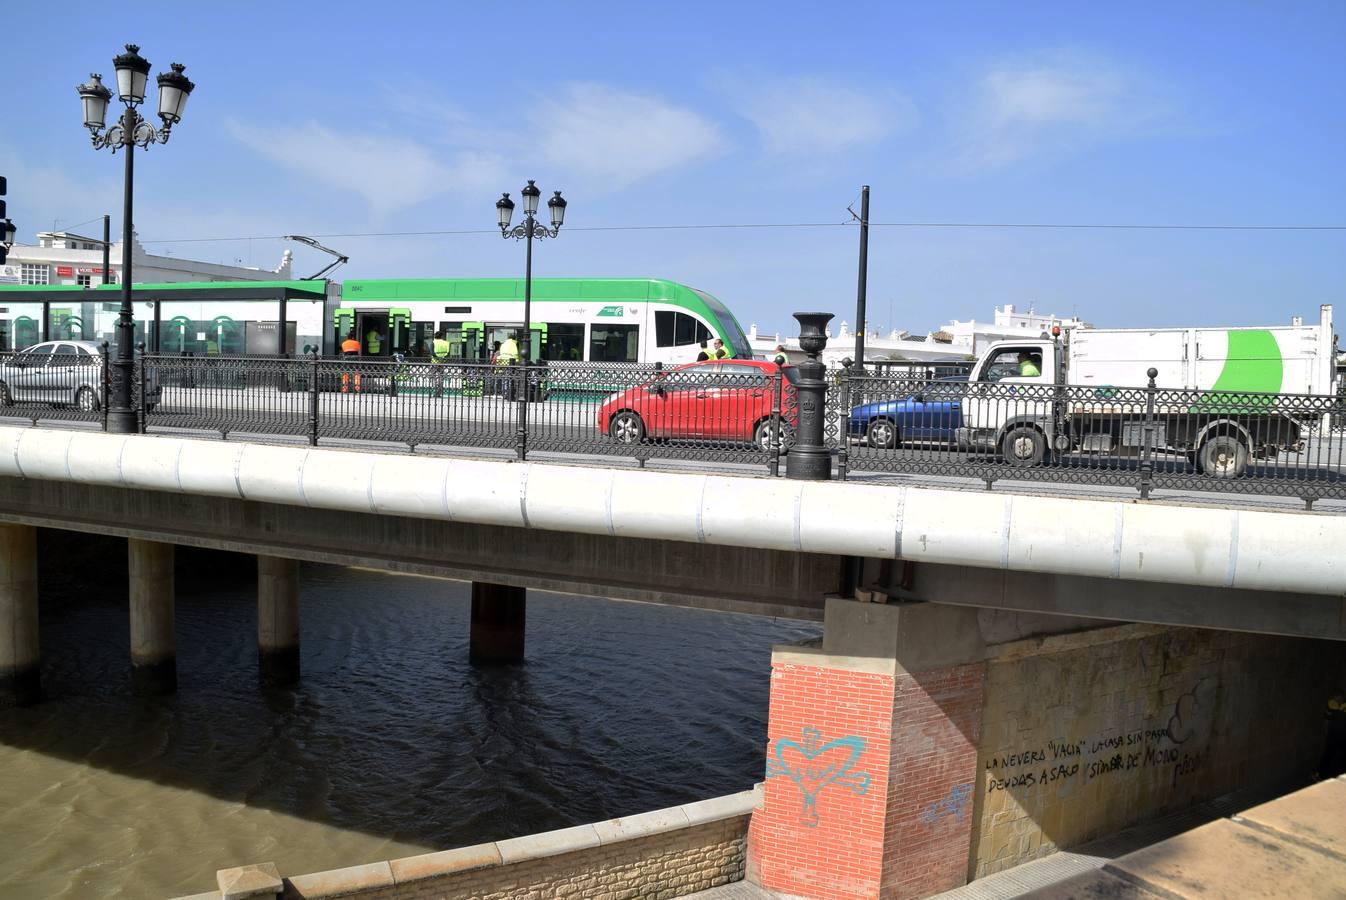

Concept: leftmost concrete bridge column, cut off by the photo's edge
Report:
left=0, top=525, right=42, bottom=708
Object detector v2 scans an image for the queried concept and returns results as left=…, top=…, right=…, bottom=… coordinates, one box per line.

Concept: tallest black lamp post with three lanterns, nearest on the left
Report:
left=77, top=44, right=195, bottom=435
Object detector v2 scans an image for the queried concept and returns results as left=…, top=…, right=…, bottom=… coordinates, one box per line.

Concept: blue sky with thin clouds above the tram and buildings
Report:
left=0, top=0, right=1346, bottom=331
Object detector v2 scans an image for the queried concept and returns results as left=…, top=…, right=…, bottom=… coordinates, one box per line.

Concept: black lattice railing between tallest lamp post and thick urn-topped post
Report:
left=143, top=355, right=793, bottom=463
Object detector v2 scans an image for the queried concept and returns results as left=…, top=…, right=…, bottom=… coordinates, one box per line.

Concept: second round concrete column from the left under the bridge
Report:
left=127, top=538, right=178, bottom=694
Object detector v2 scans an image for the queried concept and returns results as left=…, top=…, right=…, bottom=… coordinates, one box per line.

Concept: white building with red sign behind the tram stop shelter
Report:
left=0, top=231, right=291, bottom=288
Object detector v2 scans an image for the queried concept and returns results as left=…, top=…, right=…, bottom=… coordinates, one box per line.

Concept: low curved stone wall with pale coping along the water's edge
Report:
left=173, top=791, right=758, bottom=900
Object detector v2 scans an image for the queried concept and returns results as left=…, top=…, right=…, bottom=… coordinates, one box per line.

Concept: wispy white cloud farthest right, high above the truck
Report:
left=954, top=52, right=1176, bottom=168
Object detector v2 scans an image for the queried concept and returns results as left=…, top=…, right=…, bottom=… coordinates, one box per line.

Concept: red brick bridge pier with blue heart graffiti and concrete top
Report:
left=748, top=599, right=985, bottom=900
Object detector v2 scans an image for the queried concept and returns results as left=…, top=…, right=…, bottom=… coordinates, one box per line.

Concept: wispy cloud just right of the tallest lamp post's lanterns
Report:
left=229, top=121, right=505, bottom=217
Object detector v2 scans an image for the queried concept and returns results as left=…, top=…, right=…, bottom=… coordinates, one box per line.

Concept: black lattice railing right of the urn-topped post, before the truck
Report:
left=829, top=375, right=1346, bottom=502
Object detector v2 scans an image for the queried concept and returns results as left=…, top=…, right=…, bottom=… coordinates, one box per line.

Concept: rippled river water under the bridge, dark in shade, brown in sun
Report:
left=0, top=541, right=820, bottom=899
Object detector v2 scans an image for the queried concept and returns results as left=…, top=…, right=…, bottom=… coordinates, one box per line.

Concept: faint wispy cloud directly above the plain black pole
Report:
left=715, top=73, right=917, bottom=155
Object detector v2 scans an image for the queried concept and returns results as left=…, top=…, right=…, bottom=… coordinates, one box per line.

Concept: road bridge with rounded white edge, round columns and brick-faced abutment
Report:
left=0, top=417, right=1346, bottom=897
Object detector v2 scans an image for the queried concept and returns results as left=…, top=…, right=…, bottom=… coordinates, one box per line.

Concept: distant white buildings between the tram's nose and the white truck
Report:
left=748, top=304, right=1088, bottom=366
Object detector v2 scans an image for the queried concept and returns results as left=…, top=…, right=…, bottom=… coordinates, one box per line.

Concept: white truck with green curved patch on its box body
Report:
left=957, top=305, right=1337, bottom=478
